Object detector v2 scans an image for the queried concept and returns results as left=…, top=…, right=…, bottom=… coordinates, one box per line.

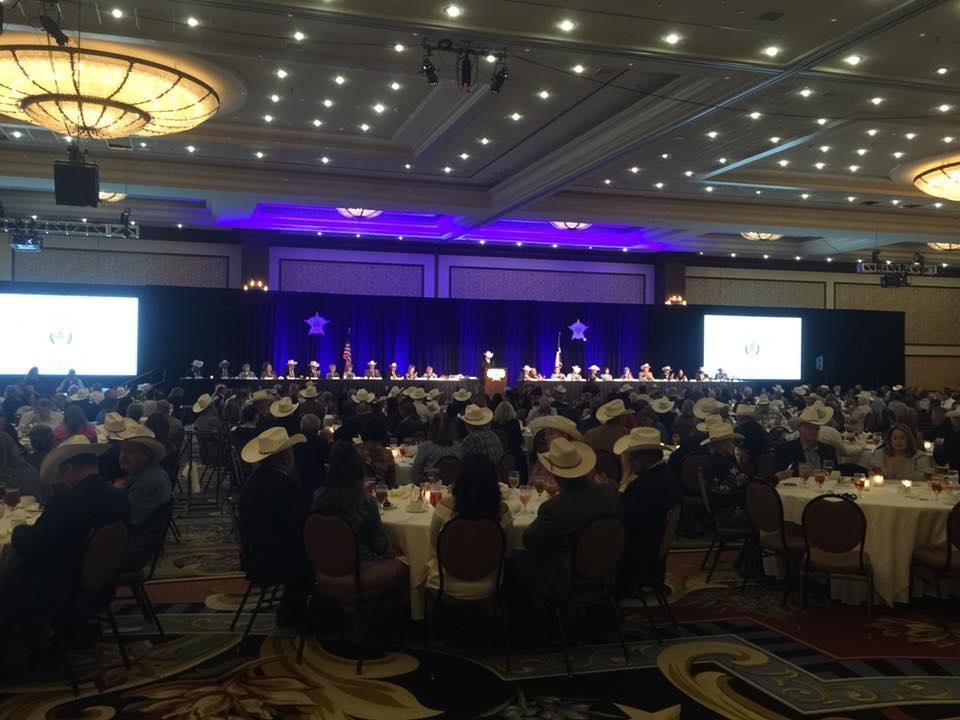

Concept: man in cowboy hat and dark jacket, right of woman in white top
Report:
left=513, top=438, right=620, bottom=598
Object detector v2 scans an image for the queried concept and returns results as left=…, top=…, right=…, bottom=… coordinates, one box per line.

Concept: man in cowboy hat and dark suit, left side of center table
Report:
left=238, top=427, right=312, bottom=627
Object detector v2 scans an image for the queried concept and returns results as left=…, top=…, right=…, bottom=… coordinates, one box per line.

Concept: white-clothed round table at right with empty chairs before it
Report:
left=777, top=479, right=957, bottom=605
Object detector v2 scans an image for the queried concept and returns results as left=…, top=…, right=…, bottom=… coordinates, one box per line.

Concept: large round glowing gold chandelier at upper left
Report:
left=0, top=44, right=220, bottom=140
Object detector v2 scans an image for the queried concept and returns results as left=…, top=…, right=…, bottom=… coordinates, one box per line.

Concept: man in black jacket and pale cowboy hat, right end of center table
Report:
left=613, top=427, right=680, bottom=590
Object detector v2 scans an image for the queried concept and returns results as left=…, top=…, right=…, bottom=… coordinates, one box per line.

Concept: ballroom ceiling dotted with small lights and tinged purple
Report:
left=0, top=0, right=960, bottom=260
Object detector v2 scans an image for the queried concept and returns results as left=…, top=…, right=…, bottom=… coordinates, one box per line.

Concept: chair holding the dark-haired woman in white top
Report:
left=424, top=517, right=511, bottom=680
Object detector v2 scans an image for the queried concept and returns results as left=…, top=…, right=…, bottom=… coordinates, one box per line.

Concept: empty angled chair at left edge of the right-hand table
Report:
left=740, top=480, right=806, bottom=607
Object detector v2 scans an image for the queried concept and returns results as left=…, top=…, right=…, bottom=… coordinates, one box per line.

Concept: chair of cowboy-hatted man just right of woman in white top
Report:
left=544, top=515, right=630, bottom=677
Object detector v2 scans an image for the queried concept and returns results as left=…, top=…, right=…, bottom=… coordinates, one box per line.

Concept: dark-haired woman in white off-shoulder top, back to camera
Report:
left=427, top=455, right=513, bottom=600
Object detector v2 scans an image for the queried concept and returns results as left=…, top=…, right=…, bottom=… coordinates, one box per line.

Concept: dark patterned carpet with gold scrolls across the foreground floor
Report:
left=0, top=516, right=960, bottom=720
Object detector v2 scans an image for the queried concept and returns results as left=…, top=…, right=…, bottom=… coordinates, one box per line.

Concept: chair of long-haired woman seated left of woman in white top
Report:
left=297, top=512, right=409, bottom=675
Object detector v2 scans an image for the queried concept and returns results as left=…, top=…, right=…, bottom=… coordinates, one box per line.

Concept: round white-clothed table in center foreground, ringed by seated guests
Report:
left=380, top=485, right=549, bottom=620
